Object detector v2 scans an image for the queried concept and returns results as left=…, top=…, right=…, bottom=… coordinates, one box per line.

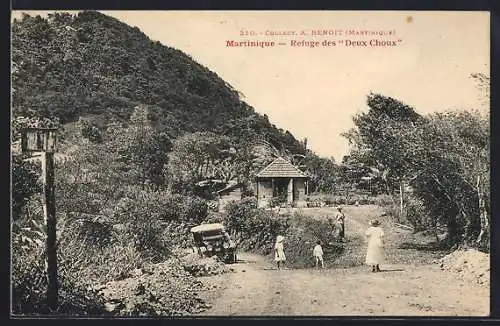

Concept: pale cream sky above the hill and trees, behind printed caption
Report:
left=13, top=11, right=490, bottom=161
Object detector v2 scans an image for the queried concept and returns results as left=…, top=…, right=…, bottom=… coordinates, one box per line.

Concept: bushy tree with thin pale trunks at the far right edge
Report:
left=412, top=111, right=490, bottom=244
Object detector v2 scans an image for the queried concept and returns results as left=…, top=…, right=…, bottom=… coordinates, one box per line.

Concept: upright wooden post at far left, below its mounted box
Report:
left=42, top=152, right=59, bottom=312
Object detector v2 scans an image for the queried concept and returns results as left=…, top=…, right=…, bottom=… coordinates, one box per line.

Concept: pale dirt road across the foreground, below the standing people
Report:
left=197, top=206, right=489, bottom=316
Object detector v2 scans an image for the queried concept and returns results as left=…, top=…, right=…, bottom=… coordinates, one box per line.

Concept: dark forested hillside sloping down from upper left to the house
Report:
left=12, top=11, right=303, bottom=152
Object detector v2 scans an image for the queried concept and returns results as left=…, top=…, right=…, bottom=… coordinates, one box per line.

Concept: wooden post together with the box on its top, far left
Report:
left=21, top=128, right=59, bottom=311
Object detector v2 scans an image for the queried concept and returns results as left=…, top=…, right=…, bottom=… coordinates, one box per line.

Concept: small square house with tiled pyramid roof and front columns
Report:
left=255, top=157, right=309, bottom=207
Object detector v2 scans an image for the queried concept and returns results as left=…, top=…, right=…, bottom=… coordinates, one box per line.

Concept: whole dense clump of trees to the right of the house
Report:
left=345, top=94, right=491, bottom=249
